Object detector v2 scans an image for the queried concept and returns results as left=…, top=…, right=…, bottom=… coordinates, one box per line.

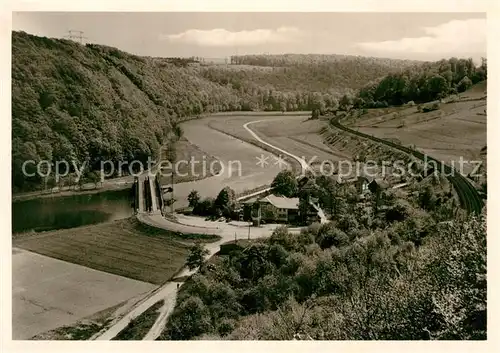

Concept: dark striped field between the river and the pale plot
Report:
left=13, top=219, right=193, bottom=284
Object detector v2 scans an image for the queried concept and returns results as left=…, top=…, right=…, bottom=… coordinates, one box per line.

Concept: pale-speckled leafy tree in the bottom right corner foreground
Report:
left=427, top=214, right=487, bottom=340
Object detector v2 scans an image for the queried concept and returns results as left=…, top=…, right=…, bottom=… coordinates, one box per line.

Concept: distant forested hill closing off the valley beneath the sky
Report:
left=201, top=54, right=422, bottom=111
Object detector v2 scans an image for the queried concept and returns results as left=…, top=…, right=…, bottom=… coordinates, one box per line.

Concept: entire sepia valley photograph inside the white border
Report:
left=5, top=1, right=490, bottom=341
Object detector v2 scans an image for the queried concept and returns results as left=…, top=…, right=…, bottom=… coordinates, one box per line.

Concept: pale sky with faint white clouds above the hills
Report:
left=12, top=12, right=487, bottom=62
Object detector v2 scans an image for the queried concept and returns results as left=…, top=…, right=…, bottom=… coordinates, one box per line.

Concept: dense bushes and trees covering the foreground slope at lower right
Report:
left=160, top=175, right=487, bottom=340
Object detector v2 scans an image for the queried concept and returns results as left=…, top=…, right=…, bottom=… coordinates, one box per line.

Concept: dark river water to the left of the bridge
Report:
left=12, top=189, right=134, bottom=233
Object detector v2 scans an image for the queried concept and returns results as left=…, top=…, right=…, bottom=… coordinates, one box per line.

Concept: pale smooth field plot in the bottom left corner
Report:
left=12, top=246, right=156, bottom=340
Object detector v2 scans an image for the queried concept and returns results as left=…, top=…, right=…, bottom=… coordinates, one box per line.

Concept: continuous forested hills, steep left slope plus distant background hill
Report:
left=12, top=32, right=416, bottom=192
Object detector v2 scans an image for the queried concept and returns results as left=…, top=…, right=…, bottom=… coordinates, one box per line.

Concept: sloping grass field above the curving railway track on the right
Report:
left=352, top=84, right=487, bottom=173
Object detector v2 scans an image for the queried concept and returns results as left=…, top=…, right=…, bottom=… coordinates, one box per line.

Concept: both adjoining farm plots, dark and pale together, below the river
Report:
left=12, top=218, right=218, bottom=339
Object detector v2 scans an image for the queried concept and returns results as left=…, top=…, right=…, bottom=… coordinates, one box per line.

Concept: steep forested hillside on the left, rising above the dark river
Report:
left=12, top=32, right=242, bottom=191
